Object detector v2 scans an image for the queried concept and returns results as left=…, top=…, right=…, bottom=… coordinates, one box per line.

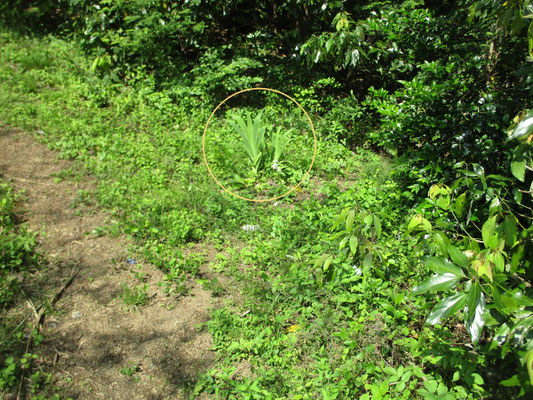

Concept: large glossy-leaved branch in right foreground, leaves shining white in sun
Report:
left=409, top=114, right=533, bottom=394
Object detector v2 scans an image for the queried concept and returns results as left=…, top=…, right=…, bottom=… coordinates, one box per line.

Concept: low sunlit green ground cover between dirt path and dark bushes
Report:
left=0, top=32, right=516, bottom=399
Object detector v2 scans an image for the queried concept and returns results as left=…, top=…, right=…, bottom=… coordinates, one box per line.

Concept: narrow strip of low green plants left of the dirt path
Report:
left=0, top=180, right=67, bottom=399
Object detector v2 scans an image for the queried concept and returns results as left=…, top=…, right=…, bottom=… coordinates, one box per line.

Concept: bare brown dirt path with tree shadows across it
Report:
left=0, top=127, right=218, bottom=400
